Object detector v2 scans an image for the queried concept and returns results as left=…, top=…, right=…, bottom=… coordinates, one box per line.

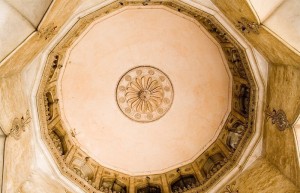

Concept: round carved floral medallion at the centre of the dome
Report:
left=116, top=66, right=174, bottom=122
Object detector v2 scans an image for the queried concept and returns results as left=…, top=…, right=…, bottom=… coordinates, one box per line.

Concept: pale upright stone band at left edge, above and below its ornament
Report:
left=0, top=75, right=34, bottom=192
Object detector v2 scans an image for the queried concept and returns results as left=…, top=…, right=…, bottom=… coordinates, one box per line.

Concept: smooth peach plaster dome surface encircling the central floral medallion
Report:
left=60, top=8, right=231, bottom=174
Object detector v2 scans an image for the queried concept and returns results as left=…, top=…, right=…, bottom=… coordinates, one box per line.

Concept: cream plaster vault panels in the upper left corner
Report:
left=0, top=0, right=52, bottom=61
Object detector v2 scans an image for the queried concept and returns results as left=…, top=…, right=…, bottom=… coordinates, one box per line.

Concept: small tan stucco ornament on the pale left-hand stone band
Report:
left=10, top=111, right=31, bottom=140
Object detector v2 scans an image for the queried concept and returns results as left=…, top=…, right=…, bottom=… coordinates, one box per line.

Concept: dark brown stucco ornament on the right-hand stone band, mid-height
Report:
left=266, top=109, right=291, bottom=131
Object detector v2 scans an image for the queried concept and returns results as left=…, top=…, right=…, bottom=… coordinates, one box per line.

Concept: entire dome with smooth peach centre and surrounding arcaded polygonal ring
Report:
left=38, top=1, right=257, bottom=193
